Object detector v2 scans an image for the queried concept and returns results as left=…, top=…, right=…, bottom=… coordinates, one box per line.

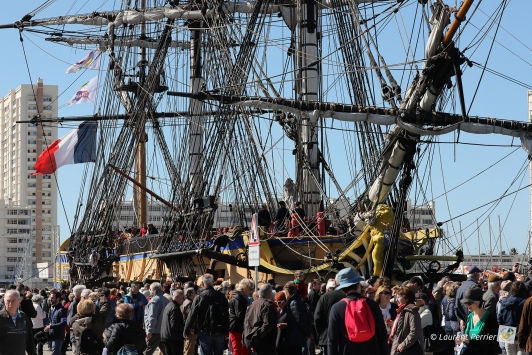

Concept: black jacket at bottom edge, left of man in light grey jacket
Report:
left=103, top=318, right=146, bottom=354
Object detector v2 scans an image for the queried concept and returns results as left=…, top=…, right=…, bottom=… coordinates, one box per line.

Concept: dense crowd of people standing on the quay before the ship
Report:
left=0, top=266, right=532, bottom=355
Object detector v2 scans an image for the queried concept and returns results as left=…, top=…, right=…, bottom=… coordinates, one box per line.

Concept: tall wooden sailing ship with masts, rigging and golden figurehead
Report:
left=0, top=0, right=532, bottom=286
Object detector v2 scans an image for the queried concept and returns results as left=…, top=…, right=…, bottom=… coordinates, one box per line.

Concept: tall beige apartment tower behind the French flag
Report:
left=0, top=79, right=58, bottom=270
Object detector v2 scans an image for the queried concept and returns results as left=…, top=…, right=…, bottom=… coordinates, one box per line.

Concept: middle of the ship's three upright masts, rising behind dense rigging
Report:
left=188, top=0, right=203, bottom=198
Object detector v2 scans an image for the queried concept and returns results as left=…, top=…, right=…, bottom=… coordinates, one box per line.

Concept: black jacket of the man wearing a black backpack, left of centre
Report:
left=183, top=287, right=229, bottom=336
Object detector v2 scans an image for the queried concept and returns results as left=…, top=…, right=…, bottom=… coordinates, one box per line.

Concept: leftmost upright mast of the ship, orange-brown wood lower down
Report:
left=135, top=0, right=148, bottom=226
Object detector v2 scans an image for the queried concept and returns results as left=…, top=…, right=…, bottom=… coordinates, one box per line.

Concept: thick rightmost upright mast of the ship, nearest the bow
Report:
left=297, top=0, right=321, bottom=217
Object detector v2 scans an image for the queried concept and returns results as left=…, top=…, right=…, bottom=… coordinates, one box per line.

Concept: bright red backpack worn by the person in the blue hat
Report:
left=342, top=298, right=375, bottom=343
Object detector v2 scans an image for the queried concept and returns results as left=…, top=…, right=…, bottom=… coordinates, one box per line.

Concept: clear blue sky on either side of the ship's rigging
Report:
left=0, top=0, right=532, bottom=260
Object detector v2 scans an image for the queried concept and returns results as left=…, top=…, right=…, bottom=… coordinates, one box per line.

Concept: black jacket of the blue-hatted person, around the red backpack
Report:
left=327, top=292, right=388, bottom=355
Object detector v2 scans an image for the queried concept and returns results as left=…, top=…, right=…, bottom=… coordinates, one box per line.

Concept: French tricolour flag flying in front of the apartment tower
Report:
left=32, top=122, right=97, bottom=175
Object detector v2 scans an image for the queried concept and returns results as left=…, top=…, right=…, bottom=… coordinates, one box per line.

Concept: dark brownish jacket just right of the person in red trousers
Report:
left=242, top=298, right=277, bottom=354
